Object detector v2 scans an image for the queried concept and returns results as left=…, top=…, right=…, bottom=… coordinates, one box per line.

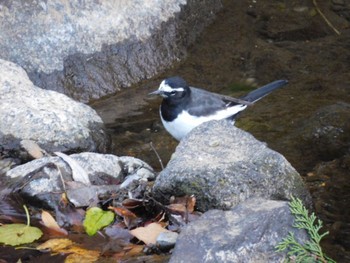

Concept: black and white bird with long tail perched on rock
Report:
left=150, top=77, right=288, bottom=141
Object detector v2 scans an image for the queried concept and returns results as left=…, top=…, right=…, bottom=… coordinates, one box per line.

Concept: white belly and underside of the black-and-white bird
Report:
left=160, top=105, right=247, bottom=141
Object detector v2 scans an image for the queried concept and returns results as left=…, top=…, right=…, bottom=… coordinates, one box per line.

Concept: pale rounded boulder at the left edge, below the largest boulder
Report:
left=0, top=60, right=110, bottom=159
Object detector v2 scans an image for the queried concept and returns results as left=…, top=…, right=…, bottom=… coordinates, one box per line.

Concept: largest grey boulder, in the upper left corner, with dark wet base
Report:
left=0, top=0, right=222, bottom=102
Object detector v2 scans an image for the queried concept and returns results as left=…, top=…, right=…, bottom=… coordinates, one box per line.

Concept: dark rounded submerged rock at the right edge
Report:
left=296, top=102, right=350, bottom=161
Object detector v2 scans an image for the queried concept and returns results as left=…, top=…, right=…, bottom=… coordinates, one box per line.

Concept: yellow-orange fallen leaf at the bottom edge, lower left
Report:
left=37, top=238, right=100, bottom=263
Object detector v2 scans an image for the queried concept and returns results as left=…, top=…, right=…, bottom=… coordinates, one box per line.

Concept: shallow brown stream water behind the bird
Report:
left=91, top=1, right=350, bottom=262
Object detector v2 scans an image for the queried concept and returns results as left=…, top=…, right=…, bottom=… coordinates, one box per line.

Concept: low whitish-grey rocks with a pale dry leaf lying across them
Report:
left=6, top=153, right=155, bottom=209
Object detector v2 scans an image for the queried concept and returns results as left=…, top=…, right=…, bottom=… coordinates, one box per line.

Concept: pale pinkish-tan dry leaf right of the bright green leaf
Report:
left=130, top=223, right=170, bottom=245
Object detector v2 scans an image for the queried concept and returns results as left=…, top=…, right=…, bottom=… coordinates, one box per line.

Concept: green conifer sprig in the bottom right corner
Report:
left=276, top=197, right=335, bottom=263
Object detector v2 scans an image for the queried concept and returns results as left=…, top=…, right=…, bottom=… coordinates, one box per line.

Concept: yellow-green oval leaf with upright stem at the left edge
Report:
left=0, top=224, right=43, bottom=246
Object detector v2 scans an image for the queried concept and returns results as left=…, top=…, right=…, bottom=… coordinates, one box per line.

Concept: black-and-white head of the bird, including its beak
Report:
left=149, top=77, right=189, bottom=99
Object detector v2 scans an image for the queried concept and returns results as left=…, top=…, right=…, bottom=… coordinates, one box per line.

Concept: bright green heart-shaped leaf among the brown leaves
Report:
left=84, top=207, right=114, bottom=236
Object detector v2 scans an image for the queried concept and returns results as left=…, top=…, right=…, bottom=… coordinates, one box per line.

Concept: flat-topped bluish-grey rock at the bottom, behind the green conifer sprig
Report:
left=170, top=199, right=307, bottom=263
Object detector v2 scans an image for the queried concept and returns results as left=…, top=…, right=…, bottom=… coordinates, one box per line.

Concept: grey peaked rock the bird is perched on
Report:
left=153, top=120, right=311, bottom=211
